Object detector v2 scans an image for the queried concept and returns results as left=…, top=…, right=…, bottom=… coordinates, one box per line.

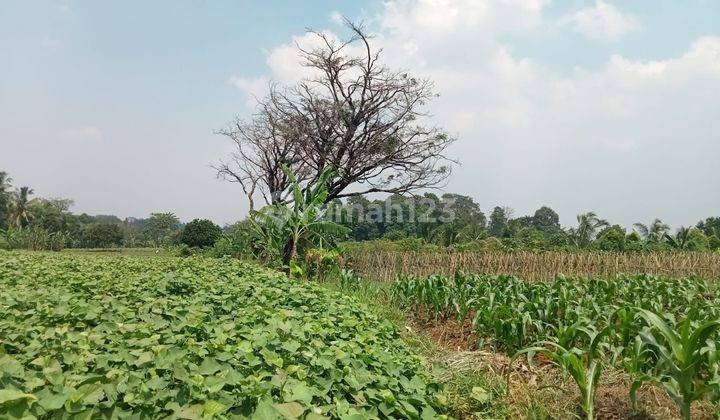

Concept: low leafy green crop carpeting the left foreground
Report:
left=0, top=253, right=442, bottom=419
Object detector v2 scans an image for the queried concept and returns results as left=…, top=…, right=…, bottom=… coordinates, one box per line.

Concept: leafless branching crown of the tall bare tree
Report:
left=216, top=21, right=453, bottom=206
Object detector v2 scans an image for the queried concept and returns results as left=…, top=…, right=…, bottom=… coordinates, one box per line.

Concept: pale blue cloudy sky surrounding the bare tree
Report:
left=0, top=0, right=720, bottom=227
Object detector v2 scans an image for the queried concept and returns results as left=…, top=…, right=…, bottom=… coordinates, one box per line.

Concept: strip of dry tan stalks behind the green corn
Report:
left=345, top=250, right=720, bottom=281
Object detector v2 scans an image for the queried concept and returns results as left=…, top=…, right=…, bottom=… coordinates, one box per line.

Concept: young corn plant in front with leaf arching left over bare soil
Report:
left=513, top=323, right=611, bottom=420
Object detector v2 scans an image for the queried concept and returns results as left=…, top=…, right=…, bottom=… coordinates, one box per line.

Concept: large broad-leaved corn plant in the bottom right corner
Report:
left=630, top=309, right=720, bottom=420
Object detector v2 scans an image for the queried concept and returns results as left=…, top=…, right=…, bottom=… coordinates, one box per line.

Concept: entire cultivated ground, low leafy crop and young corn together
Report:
left=0, top=252, right=720, bottom=419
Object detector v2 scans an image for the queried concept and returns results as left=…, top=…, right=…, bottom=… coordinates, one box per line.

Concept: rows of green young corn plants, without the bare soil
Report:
left=390, top=273, right=720, bottom=418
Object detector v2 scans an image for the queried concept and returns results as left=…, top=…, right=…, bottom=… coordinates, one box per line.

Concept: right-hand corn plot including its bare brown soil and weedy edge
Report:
left=332, top=274, right=720, bottom=419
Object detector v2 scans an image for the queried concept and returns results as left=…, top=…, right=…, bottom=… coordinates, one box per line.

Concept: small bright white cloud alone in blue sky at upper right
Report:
left=560, top=0, right=640, bottom=41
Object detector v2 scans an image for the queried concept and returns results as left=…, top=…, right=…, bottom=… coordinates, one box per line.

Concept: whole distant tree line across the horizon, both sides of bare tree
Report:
left=0, top=171, right=720, bottom=254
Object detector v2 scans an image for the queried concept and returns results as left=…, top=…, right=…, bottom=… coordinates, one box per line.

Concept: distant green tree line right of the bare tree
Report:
left=327, top=193, right=720, bottom=252
